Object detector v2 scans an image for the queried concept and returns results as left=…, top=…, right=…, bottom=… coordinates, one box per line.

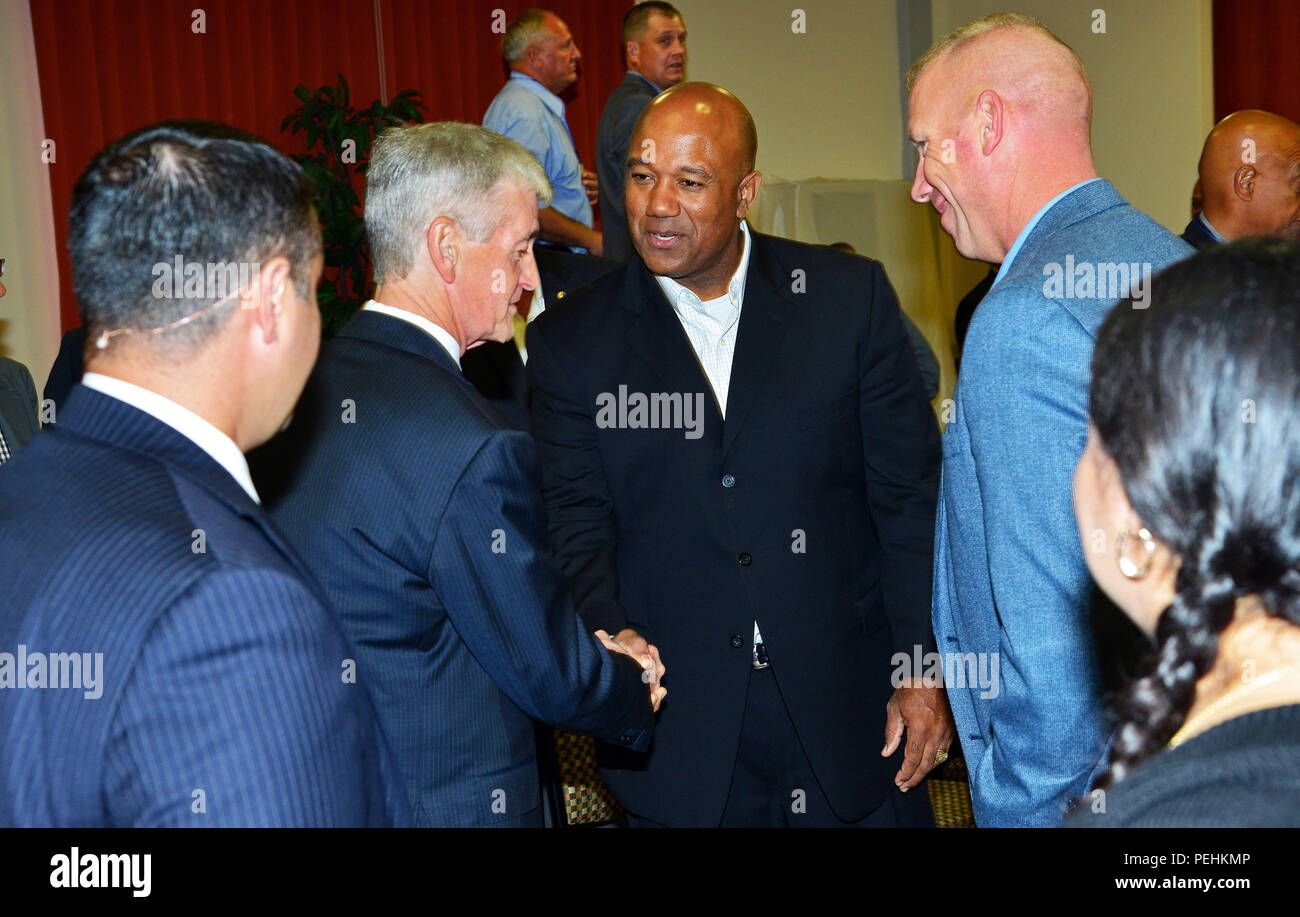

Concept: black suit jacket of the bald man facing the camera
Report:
left=528, top=227, right=939, bottom=826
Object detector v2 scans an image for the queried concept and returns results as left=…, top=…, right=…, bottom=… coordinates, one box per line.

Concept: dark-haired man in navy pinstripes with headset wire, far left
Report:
left=0, top=122, right=410, bottom=827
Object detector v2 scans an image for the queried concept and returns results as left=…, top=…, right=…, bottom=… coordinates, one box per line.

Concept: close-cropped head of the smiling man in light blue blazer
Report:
left=907, top=13, right=1097, bottom=264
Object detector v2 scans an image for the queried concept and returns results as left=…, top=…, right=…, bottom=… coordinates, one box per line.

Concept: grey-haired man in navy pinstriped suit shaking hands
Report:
left=257, top=122, right=663, bottom=826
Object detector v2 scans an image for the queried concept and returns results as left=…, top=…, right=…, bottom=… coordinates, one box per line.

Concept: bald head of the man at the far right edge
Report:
left=1197, top=108, right=1300, bottom=241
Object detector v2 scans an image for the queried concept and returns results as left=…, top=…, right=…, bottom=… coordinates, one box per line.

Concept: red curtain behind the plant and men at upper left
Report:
left=31, top=0, right=632, bottom=329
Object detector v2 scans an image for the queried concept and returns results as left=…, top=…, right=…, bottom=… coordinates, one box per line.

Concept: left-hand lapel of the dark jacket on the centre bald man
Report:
left=619, top=258, right=723, bottom=445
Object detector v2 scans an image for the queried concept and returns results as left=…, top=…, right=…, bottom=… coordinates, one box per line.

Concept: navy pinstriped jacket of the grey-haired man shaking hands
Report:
left=255, top=311, right=653, bottom=826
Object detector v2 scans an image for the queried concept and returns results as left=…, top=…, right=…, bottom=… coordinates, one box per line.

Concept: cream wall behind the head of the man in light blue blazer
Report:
left=675, top=0, right=1213, bottom=232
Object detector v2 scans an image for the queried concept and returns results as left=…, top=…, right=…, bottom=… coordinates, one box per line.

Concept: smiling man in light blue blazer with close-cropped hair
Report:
left=907, top=13, right=1191, bottom=826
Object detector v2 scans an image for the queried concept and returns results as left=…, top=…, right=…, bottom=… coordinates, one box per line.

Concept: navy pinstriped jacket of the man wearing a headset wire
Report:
left=0, top=385, right=408, bottom=827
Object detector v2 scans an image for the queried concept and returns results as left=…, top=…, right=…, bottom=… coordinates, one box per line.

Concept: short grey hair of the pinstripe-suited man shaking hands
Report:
left=365, top=121, right=551, bottom=284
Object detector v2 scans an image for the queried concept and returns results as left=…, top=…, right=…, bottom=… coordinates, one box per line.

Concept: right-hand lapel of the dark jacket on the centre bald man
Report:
left=722, top=230, right=794, bottom=457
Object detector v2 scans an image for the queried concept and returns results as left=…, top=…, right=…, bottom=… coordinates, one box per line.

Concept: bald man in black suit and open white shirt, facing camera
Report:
left=528, top=83, right=953, bottom=826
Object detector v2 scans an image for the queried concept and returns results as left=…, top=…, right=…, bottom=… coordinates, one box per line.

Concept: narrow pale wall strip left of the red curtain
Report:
left=0, top=0, right=59, bottom=393
